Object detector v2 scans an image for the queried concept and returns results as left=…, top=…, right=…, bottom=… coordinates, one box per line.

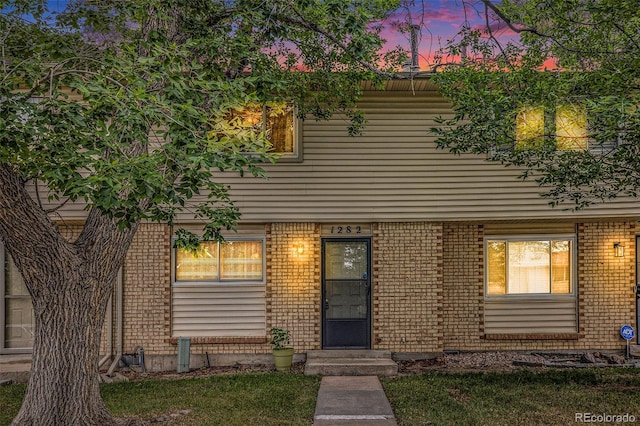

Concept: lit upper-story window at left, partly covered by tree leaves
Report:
left=232, top=103, right=300, bottom=160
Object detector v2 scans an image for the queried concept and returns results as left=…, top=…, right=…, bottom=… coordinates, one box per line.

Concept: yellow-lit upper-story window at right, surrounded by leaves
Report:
left=516, top=103, right=588, bottom=151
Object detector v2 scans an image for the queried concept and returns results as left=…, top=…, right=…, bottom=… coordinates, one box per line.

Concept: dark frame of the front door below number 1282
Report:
left=320, top=237, right=373, bottom=349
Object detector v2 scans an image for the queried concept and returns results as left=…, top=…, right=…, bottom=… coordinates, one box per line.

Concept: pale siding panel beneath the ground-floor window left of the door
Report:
left=171, top=284, right=266, bottom=337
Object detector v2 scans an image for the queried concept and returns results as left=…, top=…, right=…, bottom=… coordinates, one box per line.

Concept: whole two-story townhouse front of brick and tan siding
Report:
left=0, top=79, right=640, bottom=370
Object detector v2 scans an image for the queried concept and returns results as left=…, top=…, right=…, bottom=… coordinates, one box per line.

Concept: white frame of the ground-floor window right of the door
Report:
left=483, top=234, right=578, bottom=300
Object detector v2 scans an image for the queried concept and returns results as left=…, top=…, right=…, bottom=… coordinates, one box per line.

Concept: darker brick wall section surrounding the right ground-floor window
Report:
left=444, top=222, right=637, bottom=351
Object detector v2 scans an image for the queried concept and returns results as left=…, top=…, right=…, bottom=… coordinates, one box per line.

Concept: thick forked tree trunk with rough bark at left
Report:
left=0, top=163, right=142, bottom=426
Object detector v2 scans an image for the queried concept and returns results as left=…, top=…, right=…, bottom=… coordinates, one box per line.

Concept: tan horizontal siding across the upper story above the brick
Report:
left=28, top=90, right=640, bottom=223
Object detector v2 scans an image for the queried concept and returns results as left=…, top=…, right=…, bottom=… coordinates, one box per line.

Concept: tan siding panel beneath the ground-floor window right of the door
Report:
left=484, top=297, right=578, bottom=334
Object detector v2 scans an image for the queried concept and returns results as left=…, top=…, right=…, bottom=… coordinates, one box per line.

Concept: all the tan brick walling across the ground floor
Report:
left=105, top=221, right=637, bottom=362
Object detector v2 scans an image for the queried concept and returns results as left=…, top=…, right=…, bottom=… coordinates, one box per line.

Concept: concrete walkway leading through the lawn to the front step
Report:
left=313, top=376, right=397, bottom=426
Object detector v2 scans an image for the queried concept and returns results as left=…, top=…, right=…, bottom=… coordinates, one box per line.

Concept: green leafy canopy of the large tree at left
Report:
left=0, top=0, right=397, bottom=240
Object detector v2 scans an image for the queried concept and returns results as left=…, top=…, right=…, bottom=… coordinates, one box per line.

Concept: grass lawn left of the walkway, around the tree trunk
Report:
left=0, top=373, right=320, bottom=426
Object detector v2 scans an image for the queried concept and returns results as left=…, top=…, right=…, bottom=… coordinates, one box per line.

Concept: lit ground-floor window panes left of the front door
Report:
left=174, top=238, right=265, bottom=283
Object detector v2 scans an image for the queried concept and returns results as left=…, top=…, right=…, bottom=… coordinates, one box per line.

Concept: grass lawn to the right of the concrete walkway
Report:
left=382, top=369, right=640, bottom=426
